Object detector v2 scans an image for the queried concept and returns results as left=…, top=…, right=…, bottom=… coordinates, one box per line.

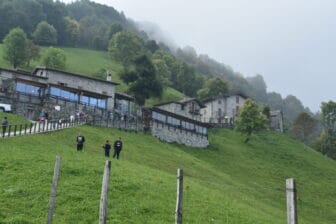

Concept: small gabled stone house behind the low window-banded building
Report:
left=154, top=98, right=205, bottom=121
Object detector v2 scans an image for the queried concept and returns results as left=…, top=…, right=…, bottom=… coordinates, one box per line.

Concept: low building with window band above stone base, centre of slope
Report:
left=144, top=107, right=209, bottom=148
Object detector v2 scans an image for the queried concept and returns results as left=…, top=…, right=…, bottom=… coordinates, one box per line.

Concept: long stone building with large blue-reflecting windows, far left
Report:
left=0, top=67, right=117, bottom=119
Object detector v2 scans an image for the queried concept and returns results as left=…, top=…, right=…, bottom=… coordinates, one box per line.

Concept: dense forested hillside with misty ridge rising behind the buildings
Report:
left=0, top=0, right=309, bottom=129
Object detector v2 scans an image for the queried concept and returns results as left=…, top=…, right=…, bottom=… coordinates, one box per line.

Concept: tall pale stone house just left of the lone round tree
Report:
left=201, top=93, right=247, bottom=124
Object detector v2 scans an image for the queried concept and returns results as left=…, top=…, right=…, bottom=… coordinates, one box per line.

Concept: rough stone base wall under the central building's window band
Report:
left=151, top=122, right=209, bottom=148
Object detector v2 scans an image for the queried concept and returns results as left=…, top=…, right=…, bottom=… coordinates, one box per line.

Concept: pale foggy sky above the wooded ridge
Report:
left=64, top=0, right=336, bottom=112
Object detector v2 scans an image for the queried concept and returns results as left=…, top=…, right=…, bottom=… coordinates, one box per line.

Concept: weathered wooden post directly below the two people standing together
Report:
left=99, top=160, right=111, bottom=224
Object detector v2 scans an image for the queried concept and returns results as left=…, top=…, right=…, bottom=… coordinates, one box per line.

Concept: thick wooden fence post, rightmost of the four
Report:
left=286, top=178, right=298, bottom=224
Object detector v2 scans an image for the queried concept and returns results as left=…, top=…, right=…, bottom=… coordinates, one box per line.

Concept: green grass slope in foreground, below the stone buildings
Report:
left=0, top=126, right=336, bottom=224
